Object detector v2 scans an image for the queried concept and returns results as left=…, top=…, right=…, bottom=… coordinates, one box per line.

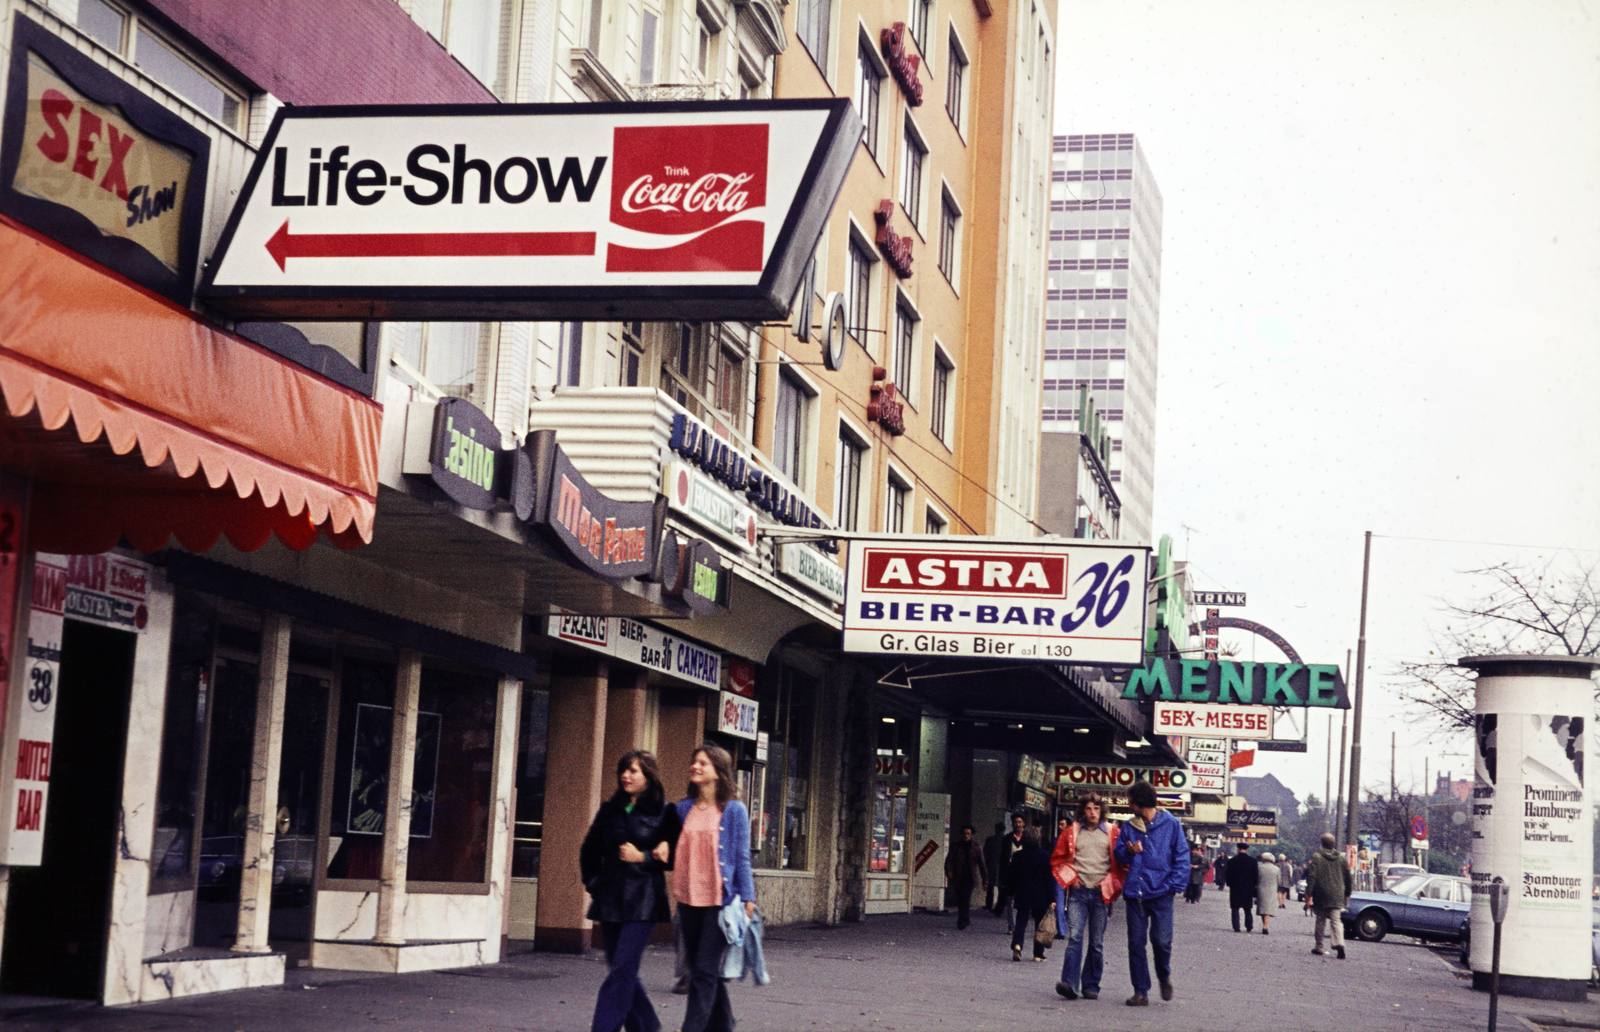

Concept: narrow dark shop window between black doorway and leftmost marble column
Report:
left=150, top=590, right=216, bottom=894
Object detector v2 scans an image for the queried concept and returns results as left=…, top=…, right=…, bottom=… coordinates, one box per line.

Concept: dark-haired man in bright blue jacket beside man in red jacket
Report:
left=1117, top=781, right=1189, bottom=1006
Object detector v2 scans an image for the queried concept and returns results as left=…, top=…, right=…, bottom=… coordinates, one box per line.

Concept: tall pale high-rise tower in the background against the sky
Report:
left=1043, top=133, right=1162, bottom=541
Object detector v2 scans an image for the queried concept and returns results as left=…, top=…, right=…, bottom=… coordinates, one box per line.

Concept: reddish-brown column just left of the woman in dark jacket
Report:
left=534, top=656, right=611, bottom=954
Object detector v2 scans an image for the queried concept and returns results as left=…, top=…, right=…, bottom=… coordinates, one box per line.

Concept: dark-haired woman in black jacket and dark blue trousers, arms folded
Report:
left=578, top=749, right=678, bottom=1032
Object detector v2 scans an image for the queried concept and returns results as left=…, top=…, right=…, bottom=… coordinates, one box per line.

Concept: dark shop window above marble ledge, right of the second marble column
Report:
left=406, top=666, right=498, bottom=883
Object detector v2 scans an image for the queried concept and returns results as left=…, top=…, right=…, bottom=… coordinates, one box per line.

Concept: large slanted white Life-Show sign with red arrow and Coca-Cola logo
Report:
left=202, top=99, right=861, bottom=320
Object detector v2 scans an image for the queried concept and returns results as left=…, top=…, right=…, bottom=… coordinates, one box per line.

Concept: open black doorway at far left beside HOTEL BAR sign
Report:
left=0, top=619, right=136, bottom=1000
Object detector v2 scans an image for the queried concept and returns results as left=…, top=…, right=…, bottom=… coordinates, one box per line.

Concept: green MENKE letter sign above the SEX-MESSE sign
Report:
left=1122, top=659, right=1350, bottom=707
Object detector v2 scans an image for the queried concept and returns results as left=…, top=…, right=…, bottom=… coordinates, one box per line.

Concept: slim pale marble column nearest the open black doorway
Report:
left=234, top=613, right=290, bottom=954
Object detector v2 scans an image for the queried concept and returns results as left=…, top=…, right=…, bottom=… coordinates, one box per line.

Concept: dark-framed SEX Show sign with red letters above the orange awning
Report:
left=0, top=14, right=211, bottom=304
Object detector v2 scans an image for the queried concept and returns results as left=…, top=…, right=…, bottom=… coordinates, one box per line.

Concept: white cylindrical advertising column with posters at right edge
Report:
left=1461, top=656, right=1600, bottom=1002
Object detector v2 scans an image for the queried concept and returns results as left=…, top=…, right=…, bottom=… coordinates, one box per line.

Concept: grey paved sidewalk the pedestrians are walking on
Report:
left=6, top=888, right=1600, bottom=1032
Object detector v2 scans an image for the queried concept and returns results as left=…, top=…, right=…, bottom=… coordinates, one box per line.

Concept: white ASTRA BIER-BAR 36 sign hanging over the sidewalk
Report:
left=845, top=536, right=1149, bottom=666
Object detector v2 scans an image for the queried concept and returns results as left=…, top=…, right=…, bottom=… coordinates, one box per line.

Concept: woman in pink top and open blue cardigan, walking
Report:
left=668, top=742, right=755, bottom=1032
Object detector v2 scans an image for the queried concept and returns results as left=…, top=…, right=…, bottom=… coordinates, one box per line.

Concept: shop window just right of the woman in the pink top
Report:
left=750, top=666, right=816, bottom=870
